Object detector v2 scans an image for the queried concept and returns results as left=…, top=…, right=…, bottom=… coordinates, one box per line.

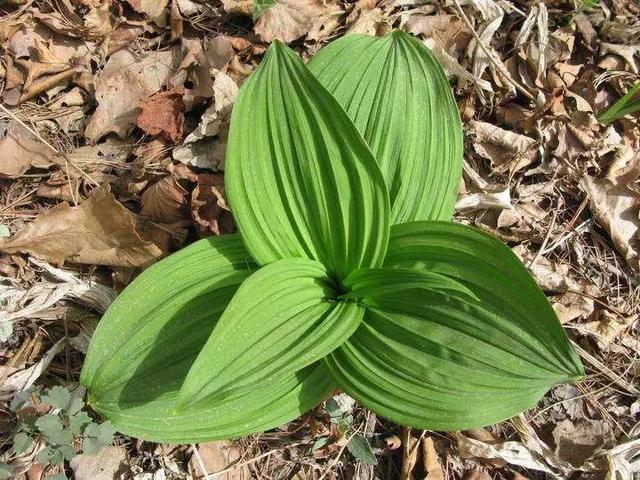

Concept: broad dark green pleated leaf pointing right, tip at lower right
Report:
left=327, top=222, right=584, bottom=430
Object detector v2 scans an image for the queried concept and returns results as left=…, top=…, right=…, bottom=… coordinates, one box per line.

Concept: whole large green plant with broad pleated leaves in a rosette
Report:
left=82, top=31, right=583, bottom=443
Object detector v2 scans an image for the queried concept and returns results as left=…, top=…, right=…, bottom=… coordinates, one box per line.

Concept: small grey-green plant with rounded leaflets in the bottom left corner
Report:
left=11, top=385, right=115, bottom=465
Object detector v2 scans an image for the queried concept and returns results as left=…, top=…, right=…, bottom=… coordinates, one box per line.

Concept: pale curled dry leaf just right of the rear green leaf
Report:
left=469, top=120, right=537, bottom=173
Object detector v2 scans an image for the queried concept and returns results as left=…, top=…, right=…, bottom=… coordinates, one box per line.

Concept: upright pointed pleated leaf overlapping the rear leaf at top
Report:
left=225, top=41, right=389, bottom=281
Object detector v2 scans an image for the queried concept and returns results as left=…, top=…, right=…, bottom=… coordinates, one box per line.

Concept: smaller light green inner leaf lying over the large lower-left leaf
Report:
left=178, top=258, right=364, bottom=409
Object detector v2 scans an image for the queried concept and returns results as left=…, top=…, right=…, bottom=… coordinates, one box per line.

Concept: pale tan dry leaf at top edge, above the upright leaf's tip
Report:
left=254, top=0, right=327, bottom=43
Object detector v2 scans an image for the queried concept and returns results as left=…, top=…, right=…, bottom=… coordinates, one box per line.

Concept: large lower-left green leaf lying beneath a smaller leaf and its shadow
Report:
left=81, top=235, right=332, bottom=443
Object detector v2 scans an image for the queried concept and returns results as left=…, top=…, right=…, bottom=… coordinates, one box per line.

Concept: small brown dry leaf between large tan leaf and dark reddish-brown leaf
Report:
left=140, top=175, right=189, bottom=223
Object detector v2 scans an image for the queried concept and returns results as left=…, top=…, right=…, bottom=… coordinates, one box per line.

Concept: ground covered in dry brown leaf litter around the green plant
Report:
left=0, top=0, right=640, bottom=480
